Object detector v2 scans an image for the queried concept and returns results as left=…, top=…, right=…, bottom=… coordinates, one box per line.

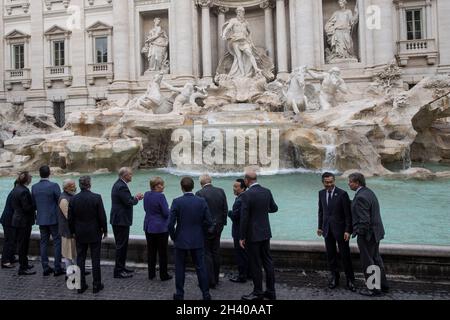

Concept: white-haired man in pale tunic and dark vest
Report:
left=58, top=179, right=77, bottom=269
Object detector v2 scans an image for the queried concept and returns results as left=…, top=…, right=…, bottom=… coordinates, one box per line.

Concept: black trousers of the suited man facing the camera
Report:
left=325, top=230, right=355, bottom=281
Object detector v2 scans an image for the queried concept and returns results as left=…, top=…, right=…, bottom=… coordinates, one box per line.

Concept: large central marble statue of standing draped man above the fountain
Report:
left=217, top=7, right=274, bottom=80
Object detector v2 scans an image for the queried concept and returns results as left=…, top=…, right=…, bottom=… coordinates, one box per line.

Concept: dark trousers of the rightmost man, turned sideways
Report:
left=357, top=236, right=389, bottom=288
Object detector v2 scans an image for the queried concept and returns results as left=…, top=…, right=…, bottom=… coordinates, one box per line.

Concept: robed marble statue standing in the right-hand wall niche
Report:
left=325, top=0, right=359, bottom=63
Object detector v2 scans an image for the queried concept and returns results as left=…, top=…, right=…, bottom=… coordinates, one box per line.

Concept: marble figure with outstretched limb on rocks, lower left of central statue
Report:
left=163, top=82, right=208, bottom=114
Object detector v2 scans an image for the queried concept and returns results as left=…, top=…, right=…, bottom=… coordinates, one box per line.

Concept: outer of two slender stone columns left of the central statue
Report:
left=197, top=0, right=212, bottom=79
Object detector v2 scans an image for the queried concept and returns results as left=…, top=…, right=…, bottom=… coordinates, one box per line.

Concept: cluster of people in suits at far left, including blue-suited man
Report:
left=1, top=166, right=66, bottom=277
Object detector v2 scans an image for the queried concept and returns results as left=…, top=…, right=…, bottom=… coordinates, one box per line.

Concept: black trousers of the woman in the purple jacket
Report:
left=145, top=232, right=169, bottom=278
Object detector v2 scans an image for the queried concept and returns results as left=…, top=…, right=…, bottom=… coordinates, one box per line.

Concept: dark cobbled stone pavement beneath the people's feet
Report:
left=0, top=261, right=450, bottom=300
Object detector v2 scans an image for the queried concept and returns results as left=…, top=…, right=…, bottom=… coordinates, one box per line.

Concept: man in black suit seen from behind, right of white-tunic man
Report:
left=68, top=176, right=108, bottom=293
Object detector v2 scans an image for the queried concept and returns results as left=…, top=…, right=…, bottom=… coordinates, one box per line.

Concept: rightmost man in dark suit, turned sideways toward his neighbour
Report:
left=348, top=173, right=389, bottom=296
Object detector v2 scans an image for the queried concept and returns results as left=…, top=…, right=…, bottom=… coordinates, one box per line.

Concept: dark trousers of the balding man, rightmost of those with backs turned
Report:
left=246, top=240, right=275, bottom=295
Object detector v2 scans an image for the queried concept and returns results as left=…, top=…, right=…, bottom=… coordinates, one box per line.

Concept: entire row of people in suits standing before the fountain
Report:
left=0, top=166, right=389, bottom=300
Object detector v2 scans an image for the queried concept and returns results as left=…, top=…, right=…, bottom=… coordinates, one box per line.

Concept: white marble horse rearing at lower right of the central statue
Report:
left=283, top=66, right=308, bottom=114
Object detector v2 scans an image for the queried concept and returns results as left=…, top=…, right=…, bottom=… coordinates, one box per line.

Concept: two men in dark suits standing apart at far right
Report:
left=317, top=172, right=389, bottom=296
